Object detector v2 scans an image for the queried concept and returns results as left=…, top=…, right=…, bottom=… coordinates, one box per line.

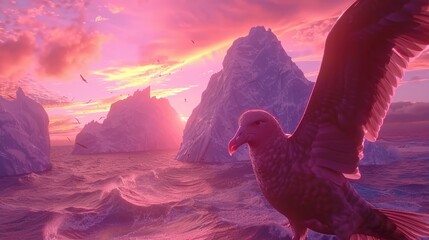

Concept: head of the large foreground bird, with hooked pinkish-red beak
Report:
left=228, top=110, right=284, bottom=155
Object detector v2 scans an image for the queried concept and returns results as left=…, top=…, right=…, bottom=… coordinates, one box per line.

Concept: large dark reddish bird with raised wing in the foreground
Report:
left=228, top=0, right=429, bottom=240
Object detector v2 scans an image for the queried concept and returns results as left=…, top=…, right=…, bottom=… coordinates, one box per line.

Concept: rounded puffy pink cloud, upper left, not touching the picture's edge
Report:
left=39, top=27, right=103, bottom=78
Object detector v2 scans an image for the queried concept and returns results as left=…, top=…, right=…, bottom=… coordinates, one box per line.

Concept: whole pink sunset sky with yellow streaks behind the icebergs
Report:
left=0, top=0, right=429, bottom=145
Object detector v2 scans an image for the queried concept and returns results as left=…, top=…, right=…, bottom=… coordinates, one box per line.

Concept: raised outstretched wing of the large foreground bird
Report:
left=291, top=0, right=429, bottom=178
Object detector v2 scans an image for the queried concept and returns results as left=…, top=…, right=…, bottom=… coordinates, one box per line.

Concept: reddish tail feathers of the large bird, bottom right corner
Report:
left=350, top=209, right=429, bottom=240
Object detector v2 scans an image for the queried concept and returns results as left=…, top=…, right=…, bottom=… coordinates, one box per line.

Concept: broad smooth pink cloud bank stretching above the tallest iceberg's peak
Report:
left=111, top=0, right=352, bottom=63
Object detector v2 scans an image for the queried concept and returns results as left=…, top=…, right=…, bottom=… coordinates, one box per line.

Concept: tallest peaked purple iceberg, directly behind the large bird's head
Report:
left=176, top=27, right=313, bottom=162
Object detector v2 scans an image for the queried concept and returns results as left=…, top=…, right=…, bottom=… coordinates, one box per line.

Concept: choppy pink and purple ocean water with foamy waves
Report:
left=0, top=147, right=429, bottom=240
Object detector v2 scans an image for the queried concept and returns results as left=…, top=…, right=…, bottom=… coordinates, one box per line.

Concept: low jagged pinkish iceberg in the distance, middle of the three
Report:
left=73, top=87, right=184, bottom=154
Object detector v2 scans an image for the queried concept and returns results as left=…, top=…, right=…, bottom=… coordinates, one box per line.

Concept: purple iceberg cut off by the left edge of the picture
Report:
left=0, top=88, right=51, bottom=176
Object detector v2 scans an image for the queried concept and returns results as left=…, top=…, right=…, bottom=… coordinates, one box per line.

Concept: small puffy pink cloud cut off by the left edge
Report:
left=0, top=33, right=35, bottom=78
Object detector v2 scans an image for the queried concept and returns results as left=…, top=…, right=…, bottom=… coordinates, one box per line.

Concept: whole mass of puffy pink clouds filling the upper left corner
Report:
left=0, top=0, right=103, bottom=79
